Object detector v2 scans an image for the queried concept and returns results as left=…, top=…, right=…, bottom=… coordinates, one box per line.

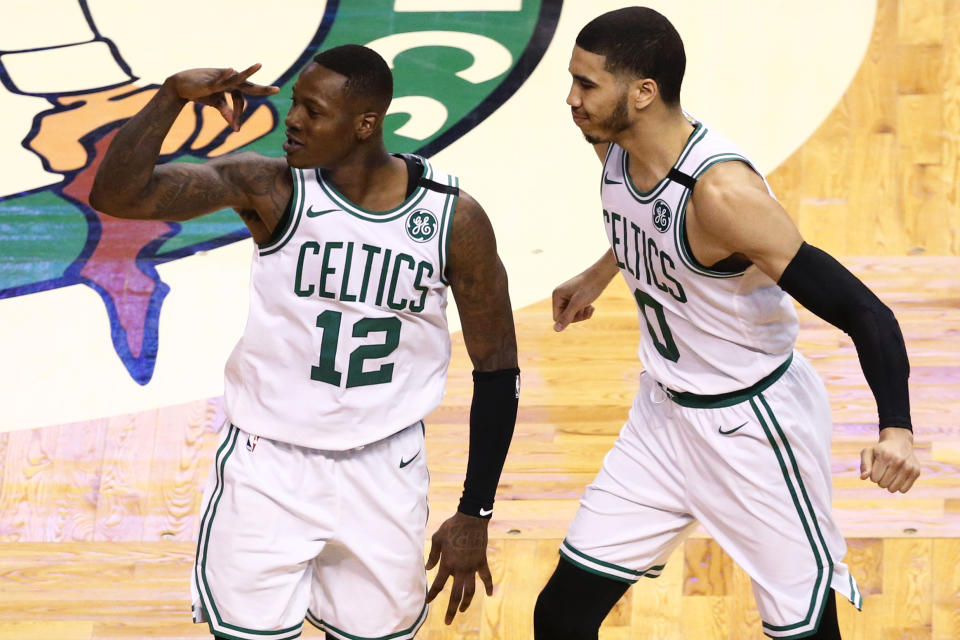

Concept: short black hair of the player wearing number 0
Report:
left=577, top=7, right=687, bottom=105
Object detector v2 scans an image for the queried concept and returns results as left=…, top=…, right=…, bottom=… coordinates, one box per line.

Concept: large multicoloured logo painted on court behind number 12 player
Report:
left=0, top=0, right=562, bottom=384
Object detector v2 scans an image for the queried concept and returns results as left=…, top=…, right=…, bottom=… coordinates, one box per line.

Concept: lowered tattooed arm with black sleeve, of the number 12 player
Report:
left=427, top=192, right=519, bottom=624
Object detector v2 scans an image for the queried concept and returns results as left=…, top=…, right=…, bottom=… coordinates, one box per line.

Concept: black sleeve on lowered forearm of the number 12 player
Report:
left=457, top=368, right=520, bottom=518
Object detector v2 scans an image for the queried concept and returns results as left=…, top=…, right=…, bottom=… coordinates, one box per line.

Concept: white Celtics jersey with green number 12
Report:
left=224, top=158, right=459, bottom=450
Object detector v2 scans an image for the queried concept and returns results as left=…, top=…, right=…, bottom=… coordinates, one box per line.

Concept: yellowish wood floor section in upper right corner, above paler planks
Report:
left=757, top=0, right=960, bottom=256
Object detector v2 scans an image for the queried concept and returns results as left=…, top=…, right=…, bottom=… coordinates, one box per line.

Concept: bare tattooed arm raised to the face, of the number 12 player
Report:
left=90, top=65, right=292, bottom=244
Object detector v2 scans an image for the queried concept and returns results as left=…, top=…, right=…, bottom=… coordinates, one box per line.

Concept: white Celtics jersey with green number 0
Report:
left=600, top=123, right=797, bottom=395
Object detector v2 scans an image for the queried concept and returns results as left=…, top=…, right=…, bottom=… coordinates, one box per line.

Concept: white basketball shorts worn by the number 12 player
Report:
left=191, top=422, right=429, bottom=640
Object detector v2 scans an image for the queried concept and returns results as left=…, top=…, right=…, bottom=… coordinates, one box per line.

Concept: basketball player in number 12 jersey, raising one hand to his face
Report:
left=90, top=45, right=520, bottom=640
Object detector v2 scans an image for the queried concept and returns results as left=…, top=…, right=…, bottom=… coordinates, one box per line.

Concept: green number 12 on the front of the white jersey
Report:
left=310, top=310, right=402, bottom=389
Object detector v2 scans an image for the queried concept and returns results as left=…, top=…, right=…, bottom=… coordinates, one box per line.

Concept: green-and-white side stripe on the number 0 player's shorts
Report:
left=750, top=394, right=833, bottom=638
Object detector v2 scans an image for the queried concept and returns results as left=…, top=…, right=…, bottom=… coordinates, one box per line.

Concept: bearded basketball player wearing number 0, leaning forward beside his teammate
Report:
left=535, top=7, right=919, bottom=640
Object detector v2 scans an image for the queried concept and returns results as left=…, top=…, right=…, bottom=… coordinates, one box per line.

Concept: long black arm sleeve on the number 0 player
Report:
left=778, top=242, right=911, bottom=429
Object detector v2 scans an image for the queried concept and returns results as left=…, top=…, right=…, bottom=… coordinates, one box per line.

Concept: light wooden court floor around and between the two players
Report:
left=0, top=0, right=960, bottom=640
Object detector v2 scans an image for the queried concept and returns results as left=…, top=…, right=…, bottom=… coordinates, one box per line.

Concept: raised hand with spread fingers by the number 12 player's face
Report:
left=167, top=62, right=280, bottom=131
